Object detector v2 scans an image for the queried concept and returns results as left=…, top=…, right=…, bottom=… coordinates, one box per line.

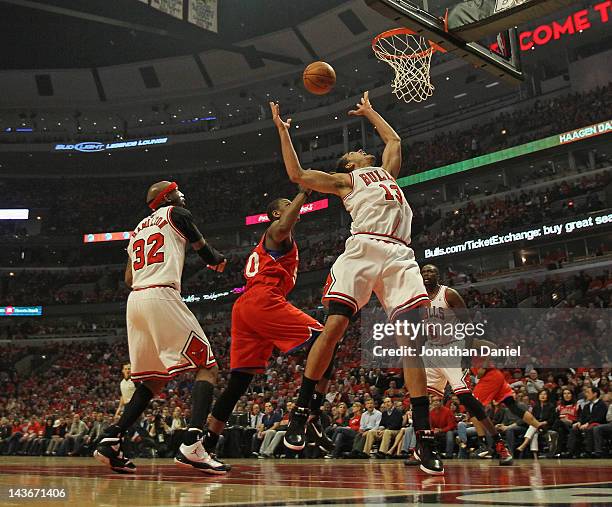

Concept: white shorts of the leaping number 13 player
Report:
left=323, top=236, right=429, bottom=320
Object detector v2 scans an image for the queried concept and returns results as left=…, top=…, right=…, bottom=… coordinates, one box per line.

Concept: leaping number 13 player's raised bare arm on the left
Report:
left=270, top=102, right=352, bottom=197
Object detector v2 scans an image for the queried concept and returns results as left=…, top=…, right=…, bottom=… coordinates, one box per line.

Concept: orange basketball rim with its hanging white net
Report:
left=372, top=32, right=434, bottom=102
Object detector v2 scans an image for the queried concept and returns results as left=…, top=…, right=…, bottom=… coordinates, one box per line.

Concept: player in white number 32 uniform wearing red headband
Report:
left=94, top=181, right=229, bottom=474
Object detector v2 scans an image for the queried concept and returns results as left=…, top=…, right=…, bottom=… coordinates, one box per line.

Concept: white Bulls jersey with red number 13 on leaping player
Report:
left=343, top=167, right=412, bottom=244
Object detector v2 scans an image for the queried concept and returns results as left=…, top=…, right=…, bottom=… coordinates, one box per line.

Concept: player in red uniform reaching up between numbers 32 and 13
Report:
left=204, top=189, right=333, bottom=451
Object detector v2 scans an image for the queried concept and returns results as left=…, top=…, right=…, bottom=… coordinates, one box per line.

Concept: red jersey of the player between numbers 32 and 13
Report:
left=244, top=234, right=300, bottom=296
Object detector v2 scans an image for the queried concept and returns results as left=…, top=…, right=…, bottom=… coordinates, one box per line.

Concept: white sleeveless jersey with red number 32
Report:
left=128, top=206, right=187, bottom=292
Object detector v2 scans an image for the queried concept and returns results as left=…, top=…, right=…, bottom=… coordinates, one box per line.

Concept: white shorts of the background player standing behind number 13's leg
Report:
left=423, top=340, right=471, bottom=396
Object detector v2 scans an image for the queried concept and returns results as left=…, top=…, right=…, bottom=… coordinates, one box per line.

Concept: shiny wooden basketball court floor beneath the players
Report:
left=0, top=457, right=612, bottom=507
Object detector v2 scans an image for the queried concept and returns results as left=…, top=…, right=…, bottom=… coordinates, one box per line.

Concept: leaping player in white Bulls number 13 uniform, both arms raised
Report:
left=270, top=92, right=444, bottom=475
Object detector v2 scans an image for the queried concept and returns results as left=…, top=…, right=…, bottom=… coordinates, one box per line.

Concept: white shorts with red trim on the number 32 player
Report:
left=127, top=287, right=216, bottom=381
